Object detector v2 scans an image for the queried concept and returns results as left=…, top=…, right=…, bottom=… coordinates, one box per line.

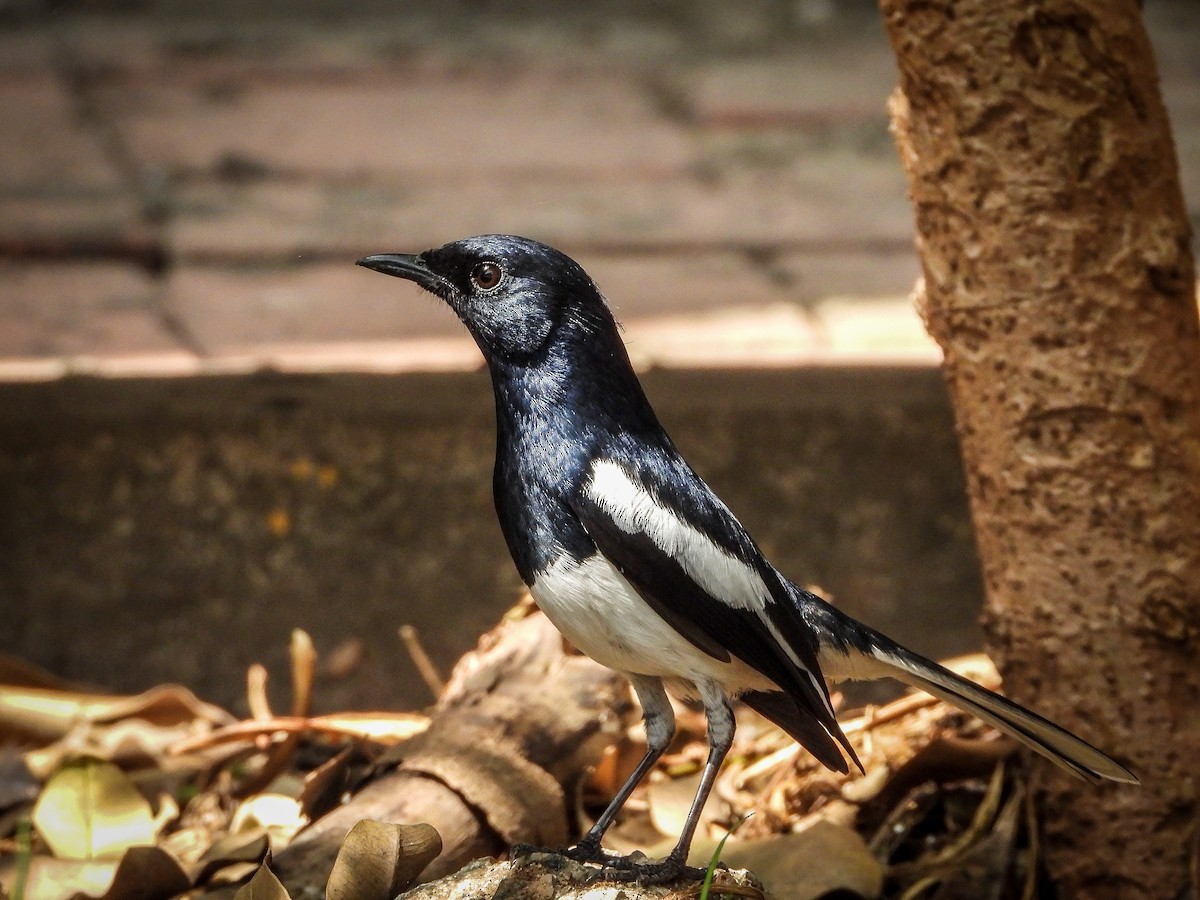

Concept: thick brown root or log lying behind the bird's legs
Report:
left=271, top=612, right=634, bottom=896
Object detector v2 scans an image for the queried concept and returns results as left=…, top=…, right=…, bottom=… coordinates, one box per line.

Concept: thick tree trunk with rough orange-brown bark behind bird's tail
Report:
left=881, top=0, right=1200, bottom=898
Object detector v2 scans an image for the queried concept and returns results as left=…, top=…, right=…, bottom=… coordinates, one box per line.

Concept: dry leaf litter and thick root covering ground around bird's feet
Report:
left=0, top=605, right=1038, bottom=900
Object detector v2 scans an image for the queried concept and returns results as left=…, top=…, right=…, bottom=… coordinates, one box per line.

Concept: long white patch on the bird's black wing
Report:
left=587, top=460, right=772, bottom=619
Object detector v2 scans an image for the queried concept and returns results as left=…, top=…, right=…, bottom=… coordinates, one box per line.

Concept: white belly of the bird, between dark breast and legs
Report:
left=529, top=553, right=779, bottom=695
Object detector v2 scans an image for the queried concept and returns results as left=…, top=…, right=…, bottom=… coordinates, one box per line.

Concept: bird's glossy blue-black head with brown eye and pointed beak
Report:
left=358, top=240, right=616, bottom=364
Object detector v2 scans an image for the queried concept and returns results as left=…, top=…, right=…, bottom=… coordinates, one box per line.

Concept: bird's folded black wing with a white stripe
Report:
left=572, top=455, right=858, bottom=772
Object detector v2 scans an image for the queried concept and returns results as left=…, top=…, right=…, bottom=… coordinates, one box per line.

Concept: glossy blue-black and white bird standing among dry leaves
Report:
left=359, top=235, right=1138, bottom=881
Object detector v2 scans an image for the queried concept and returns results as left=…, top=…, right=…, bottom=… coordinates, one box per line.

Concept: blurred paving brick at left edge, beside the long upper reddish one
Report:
left=0, top=72, right=120, bottom=193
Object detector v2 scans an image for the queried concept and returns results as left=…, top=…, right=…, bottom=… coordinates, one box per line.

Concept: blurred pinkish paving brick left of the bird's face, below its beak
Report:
left=159, top=259, right=462, bottom=358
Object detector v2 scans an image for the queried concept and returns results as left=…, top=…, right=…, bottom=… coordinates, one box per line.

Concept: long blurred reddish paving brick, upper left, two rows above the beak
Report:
left=98, top=68, right=689, bottom=179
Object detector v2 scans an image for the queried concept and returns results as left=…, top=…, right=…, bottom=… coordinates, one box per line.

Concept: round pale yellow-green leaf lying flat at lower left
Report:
left=34, top=757, right=156, bottom=859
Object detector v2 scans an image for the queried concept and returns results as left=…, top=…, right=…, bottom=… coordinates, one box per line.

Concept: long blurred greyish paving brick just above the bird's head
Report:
left=167, top=155, right=912, bottom=259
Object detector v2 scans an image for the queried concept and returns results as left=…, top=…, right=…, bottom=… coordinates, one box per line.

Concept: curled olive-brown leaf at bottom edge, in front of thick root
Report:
left=325, top=820, right=442, bottom=900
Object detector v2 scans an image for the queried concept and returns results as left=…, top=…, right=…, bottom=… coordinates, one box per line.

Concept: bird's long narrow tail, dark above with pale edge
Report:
left=849, top=624, right=1138, bottom=785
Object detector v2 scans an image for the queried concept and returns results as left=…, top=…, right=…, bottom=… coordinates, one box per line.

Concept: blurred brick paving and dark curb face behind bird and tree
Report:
left=0, top=0, right=1200, bottom=709
